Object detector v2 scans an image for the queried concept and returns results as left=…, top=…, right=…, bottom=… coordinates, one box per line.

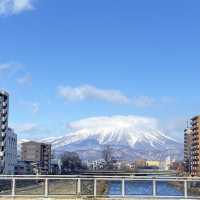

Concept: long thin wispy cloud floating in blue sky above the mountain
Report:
left=58, top=85, right=175, bottom=108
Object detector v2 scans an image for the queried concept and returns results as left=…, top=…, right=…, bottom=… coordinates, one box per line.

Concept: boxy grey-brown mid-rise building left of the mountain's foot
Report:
left=21, top=141, right=51, bottom=175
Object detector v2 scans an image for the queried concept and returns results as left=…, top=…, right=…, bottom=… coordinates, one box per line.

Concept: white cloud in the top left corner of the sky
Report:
left=0, top=0, right=34, bottom=16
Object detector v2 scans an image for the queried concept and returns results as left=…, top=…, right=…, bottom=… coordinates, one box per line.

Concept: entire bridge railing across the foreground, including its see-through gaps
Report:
left=0, top=175, right=200, bottom=199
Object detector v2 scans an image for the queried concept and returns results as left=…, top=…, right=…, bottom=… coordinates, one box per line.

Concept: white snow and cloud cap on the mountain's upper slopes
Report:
left=48, top=115, right=176, bottom=148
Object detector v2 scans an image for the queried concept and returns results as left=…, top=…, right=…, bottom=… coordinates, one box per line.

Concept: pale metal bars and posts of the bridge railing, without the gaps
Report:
left=0, top=175, right=200, bottom=199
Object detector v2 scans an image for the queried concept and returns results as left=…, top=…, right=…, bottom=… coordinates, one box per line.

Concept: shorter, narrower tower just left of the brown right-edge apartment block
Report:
left=184, top=128, right=192, bottom=173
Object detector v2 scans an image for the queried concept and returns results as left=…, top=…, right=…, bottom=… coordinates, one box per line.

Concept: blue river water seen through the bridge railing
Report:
left=108, top=181, right=184, bottom=196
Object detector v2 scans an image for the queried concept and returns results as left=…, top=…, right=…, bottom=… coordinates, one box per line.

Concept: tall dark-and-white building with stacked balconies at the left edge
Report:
left=0, top=90, right=9, bottom=174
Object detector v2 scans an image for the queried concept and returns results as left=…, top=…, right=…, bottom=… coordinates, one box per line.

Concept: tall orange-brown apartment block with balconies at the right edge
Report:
left=191, top=116, right=200, bottom=176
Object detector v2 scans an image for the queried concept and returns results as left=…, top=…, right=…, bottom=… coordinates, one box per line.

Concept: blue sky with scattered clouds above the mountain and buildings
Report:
left=0, top=0, right=200, bottom=141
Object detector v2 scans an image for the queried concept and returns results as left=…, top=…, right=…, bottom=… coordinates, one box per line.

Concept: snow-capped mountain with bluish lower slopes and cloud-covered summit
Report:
left=43, top=116, right=182, bottom=159
